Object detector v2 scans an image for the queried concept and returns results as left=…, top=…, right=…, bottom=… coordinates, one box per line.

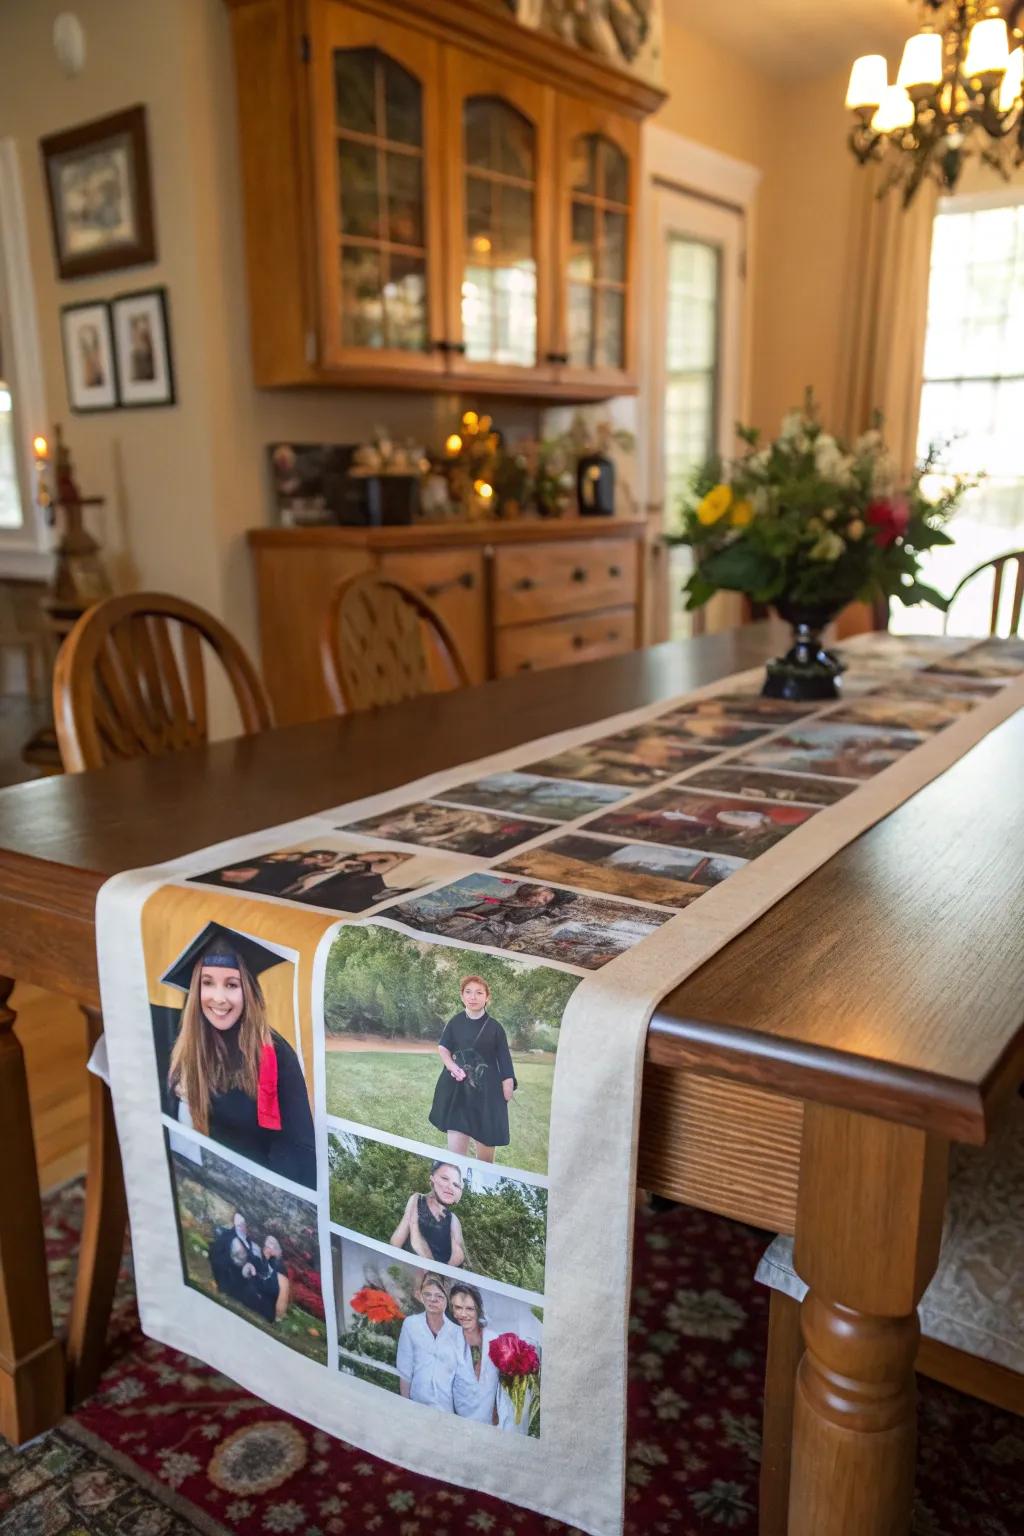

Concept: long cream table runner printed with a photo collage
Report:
left=97, top=637, right=1024, bottom=1536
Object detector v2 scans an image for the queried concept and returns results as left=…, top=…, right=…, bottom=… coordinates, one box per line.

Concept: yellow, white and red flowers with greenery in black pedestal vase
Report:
left=680, top=392, right=972, bottom=613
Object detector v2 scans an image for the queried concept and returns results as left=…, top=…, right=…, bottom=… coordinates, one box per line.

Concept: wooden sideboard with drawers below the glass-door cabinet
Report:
left=249, top=518, right=646, bottom=725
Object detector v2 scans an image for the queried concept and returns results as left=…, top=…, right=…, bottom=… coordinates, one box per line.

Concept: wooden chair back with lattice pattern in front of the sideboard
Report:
left=321, top=574, right=470, bottom=713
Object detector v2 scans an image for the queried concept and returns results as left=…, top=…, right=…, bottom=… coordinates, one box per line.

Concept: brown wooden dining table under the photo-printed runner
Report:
left=0, top=625, right=1024, bottom=1536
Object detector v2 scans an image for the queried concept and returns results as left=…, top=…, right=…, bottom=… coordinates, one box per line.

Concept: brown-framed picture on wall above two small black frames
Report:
left=40, top=106, right=157, bottom=278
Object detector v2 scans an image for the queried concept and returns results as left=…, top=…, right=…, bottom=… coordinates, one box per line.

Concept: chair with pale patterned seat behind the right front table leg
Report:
left=757, top=1098, right=1024, bottom=1536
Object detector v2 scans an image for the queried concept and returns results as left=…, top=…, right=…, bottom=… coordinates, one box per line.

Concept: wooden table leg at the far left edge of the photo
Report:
left=0, top=977, right=64, bottom=1445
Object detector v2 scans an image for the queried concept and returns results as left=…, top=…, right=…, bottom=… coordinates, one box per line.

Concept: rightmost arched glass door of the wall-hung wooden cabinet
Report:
left=559, top=101, right=636, bottom=381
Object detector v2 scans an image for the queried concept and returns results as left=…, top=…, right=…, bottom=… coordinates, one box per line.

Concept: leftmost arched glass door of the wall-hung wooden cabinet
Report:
left=318, top=11, right=444, bottom=370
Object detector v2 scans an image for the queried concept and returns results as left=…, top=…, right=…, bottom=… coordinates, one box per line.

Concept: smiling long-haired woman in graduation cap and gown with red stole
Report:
left=163, top=923, right=316, bottom=1189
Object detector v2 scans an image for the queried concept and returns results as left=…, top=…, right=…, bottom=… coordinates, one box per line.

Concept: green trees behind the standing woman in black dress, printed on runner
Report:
left=324, top=926, right=577, bottom=1051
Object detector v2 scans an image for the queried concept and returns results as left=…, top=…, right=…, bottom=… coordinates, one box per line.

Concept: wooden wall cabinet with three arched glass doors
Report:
left=227, top=0, right=660, bottom=401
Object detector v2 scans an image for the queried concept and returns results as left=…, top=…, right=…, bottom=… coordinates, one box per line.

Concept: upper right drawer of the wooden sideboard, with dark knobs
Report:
left=494, top=539, right=637, bottom=625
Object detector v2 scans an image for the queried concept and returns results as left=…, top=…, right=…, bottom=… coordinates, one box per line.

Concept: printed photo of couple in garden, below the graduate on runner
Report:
left=164, top=1129, right=327, bottom=1364
